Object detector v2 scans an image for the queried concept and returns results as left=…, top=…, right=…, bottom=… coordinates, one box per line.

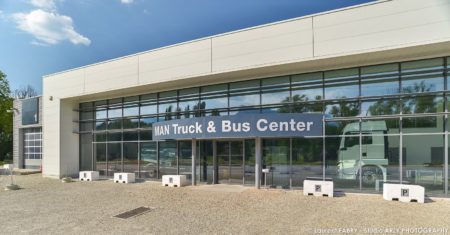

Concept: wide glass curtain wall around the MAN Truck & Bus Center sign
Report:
left=79, top=57, right=450, bottom=195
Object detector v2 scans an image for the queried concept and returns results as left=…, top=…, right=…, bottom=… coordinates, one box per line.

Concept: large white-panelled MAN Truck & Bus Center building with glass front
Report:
left=42, top=0, right=450, bottom=196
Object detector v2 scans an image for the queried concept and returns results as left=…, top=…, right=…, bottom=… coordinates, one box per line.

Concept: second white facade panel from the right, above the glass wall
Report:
left=212, top=18, right=313, bottom=72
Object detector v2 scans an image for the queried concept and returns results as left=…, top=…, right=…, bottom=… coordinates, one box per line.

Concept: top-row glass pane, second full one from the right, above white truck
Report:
left=361, top=64, right=400, bottom=96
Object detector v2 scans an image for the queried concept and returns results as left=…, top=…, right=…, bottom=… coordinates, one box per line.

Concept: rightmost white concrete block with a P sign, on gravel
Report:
left=383, top=184, right=425, bottom=203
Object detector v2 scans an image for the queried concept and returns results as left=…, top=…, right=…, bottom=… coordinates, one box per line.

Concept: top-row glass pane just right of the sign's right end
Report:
left=324, top=68, right=359, bottom=99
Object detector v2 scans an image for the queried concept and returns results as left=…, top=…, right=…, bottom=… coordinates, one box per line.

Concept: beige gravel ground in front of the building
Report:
left=0, top=175, right=450, bottom=234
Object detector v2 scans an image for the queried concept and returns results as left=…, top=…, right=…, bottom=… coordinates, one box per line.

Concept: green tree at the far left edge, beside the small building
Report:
left=0, top=71, right=13, bottom=161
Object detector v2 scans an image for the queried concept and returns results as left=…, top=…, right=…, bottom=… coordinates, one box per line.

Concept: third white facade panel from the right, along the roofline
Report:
left=139, top=39, right=211, bottom=84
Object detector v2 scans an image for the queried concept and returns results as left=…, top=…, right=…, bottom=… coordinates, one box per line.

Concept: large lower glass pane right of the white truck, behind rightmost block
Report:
left=403, top=135, right=444, bottom=196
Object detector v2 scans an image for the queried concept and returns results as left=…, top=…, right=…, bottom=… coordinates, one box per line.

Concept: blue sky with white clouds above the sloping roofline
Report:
left=0, top=0, right=370, bottom=94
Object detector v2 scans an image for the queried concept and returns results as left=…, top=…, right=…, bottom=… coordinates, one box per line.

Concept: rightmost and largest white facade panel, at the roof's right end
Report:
left=314, top=0, right=450, bottom=56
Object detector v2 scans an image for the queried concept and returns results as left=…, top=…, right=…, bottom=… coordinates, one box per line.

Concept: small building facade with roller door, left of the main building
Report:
left=13, top=97, right=43, bottom=169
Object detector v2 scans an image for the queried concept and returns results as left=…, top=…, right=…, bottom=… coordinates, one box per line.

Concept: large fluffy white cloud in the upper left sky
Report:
left=13, top=9, right=91, bottom=46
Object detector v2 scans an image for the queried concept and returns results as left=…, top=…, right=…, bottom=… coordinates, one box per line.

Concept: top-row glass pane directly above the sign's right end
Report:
left=291, top=73, right=323, bottom=101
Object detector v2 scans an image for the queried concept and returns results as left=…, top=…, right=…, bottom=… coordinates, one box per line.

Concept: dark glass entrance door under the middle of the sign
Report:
left=217, top=141, right=244, bottom=184
